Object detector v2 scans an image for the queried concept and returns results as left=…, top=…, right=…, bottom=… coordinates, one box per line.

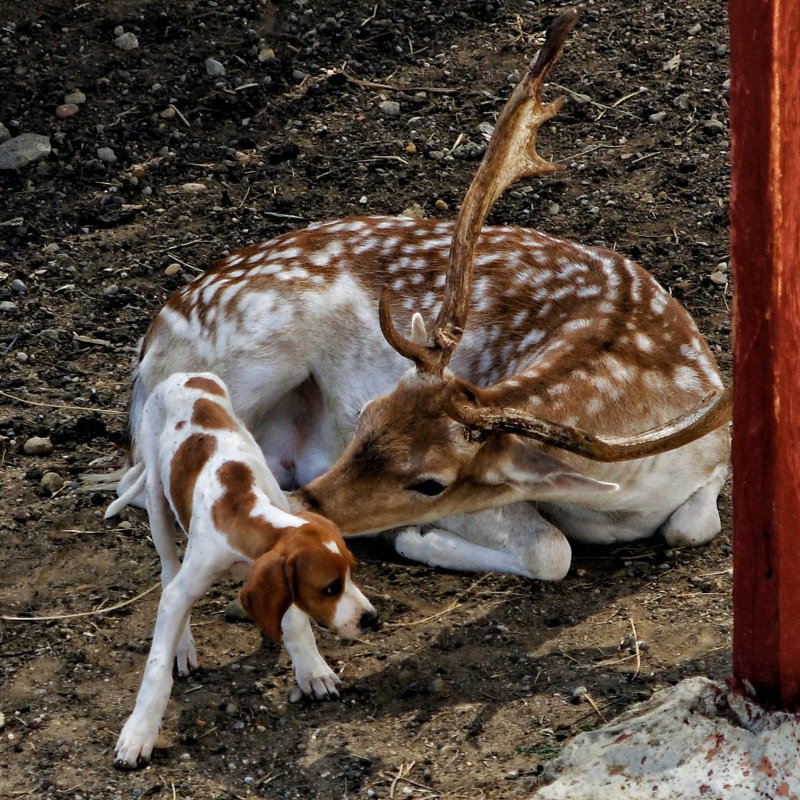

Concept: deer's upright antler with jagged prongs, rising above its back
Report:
left=379, top=8, right=582, bottom=377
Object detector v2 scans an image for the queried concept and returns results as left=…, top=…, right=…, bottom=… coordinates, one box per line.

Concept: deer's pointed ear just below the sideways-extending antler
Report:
left=476, top=434, right=619, bottom=501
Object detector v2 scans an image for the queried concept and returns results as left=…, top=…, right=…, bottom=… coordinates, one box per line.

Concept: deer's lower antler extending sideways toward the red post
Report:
left=445, top=386, right=733, bottom=462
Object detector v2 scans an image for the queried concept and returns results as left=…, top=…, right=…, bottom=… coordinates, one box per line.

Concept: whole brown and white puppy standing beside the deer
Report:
left=105, top=373, right=377, bottom=769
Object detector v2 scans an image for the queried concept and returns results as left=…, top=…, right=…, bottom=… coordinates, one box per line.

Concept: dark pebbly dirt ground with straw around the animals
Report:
left=0, top=0, right=731, bottom=800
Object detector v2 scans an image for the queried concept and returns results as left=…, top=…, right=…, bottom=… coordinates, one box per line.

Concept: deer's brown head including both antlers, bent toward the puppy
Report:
left=294, top=9, right=731, bottom=534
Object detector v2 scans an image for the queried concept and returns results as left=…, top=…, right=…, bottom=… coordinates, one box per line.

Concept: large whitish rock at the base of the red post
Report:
left=534, top=678, right=800, bottom=800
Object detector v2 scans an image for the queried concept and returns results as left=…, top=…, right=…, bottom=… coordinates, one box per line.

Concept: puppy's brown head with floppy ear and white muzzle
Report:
left=240, top=512, right=378, bottom=642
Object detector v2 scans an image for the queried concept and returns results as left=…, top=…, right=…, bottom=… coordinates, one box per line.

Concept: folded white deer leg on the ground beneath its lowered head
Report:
left=394, top=503, right=572, bottom=581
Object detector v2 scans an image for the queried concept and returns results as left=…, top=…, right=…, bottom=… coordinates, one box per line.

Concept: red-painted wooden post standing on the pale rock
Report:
left=728, top=0, right=800, bottom=710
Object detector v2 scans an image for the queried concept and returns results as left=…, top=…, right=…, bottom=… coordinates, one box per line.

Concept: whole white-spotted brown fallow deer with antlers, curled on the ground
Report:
left=122, top=10, right=731, bottom=580
